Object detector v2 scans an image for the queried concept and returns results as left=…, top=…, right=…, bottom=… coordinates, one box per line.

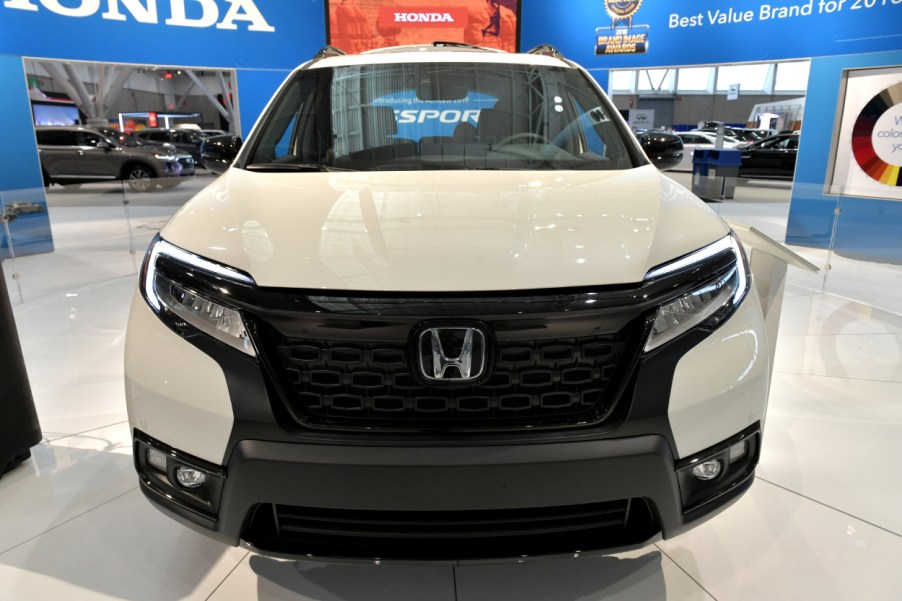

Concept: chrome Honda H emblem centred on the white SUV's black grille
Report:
left=417, top=327, right=486, bottom=383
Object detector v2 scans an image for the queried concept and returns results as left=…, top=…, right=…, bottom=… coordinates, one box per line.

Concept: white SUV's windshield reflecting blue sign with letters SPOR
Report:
left=244, top=63, right=635, bottom=171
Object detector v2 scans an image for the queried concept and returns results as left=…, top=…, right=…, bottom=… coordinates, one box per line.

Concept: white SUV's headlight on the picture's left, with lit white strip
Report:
left=141, top=236, right=257, bottom=356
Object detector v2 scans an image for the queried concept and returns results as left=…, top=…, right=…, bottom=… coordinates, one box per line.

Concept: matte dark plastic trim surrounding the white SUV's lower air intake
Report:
left=141, top=426, right=753, bottom=563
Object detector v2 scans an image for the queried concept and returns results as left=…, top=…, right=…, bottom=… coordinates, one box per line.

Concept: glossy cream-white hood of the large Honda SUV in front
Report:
left=162, top=165, right=729, bottom=292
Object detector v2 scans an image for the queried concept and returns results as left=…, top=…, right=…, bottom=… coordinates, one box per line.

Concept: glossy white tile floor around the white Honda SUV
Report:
left=0, top=174, right=902, bottom=601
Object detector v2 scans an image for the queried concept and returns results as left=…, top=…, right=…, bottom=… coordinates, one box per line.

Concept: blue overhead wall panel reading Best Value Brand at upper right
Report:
left=520, top=0, right=902, bottom=69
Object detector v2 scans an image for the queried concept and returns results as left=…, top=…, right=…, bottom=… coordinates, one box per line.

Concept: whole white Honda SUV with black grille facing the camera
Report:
left=126, top=43, right=808, bottom=561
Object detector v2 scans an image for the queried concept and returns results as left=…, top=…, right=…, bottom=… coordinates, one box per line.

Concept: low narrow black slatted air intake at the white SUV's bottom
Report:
left=242, top=499, right=658, bottom=560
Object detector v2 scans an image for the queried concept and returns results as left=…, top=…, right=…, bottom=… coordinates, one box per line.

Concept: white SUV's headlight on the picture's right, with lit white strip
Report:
left=645, top=234, right=749, bottom=352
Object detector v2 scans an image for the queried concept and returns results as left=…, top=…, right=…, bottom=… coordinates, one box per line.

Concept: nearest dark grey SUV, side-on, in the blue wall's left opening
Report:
left=35, top=127, right=183, bottom=192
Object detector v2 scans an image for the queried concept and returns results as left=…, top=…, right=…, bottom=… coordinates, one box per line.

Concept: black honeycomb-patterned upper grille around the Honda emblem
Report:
left=274, top=334, right=626, bottom=429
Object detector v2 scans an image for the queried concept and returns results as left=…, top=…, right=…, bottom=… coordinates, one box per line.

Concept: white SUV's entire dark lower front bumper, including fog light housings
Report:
left=134, top=423, right=760, bottom=562
